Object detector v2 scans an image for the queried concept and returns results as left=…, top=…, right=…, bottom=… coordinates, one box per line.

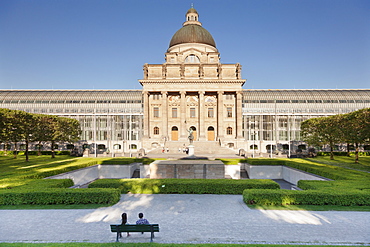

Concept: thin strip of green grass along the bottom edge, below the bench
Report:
left=0, top=243, right=364, bottom=247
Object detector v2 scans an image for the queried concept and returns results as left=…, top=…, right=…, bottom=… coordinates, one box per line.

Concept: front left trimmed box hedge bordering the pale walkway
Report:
left=0, top=189, right=121, bottom=205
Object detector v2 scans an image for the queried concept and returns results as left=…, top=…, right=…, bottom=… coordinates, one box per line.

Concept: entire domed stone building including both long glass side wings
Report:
left=0, top=8, right=370, bottom=156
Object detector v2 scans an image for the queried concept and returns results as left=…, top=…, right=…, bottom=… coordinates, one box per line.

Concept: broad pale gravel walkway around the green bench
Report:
left=0, top=194, right=370, bottom=246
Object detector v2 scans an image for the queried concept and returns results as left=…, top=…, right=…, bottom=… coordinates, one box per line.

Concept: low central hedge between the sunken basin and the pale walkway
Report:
left=89, top=179, right=280, bottom=195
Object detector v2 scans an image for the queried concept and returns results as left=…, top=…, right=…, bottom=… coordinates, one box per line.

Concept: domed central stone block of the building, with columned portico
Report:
left=139, top=8, right=246, bottom=150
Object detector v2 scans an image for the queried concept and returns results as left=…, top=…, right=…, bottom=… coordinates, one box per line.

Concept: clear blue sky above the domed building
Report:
left=0, top=0, right=370, bottom=89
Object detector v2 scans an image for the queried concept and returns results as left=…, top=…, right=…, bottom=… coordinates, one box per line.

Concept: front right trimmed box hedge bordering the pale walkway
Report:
left=243, top=189, right=370, bottom=206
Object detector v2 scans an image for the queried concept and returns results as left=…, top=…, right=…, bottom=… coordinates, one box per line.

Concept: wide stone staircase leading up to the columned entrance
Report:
left=149, top=141, right=237, bottom=155
